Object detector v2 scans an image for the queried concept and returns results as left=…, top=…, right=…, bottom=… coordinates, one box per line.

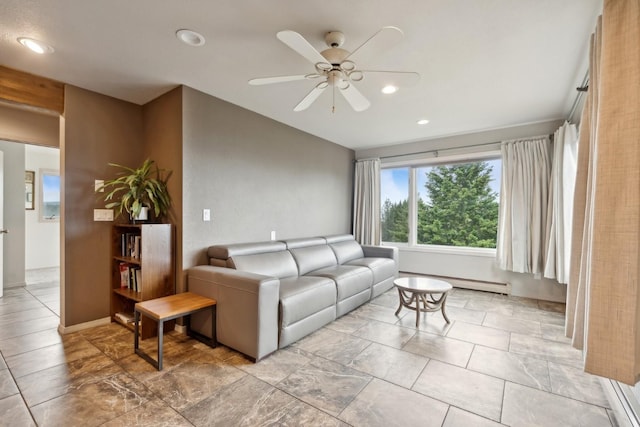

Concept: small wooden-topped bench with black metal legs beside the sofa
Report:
left=133, top=292, right=217, bottom=371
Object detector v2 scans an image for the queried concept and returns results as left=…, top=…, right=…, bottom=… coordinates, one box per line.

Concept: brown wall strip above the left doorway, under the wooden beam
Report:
left=0, top=104, right=60, bottom=147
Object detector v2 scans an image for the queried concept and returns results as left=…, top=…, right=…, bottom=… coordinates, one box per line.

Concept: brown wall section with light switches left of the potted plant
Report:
left=60, top=86, right=143, bottom=326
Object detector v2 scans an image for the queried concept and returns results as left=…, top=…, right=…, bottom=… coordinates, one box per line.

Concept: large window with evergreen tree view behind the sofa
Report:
left=380, top=155, right=501, bottom=248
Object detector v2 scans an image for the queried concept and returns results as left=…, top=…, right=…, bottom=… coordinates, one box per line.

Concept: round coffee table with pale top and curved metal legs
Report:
left=393, top=277, right=453, bottom=328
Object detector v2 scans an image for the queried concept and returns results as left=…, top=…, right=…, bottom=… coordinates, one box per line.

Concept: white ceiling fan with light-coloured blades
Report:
left=249, top=27, right=420, bottom=111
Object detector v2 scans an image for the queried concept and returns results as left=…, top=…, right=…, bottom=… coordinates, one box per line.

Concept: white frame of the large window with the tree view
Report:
left=380, top=150, right=502, bottom=257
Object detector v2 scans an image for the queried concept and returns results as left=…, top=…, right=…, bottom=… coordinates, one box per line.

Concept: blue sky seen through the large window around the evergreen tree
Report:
left=380, top=159, right=501, bottom=203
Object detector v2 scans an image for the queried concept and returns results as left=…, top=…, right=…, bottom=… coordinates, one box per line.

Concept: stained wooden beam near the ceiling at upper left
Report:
left=0, top=65, right=64, bottom=114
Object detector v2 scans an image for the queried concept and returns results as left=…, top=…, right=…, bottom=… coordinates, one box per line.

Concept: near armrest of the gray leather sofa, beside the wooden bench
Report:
left=187, top=265, right=280, bottom=361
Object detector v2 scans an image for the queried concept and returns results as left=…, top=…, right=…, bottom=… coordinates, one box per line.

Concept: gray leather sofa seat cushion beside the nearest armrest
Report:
left=280, top=276, right=336, bottom=327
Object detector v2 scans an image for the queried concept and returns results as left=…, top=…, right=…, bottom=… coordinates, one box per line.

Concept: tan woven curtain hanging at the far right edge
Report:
left=566, top=0, right=640, bottom=384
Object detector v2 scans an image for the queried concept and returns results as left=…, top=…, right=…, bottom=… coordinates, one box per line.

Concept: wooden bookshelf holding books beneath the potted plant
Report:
left=111, top=224, right=175, bottom=339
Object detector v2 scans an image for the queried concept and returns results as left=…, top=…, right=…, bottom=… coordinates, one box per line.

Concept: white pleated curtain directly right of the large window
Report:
left=496, top=136, right=551, bottom=274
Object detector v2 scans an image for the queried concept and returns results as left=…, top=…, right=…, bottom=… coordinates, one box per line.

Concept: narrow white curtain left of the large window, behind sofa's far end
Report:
left=353, top=159, right=381, bottom=245
